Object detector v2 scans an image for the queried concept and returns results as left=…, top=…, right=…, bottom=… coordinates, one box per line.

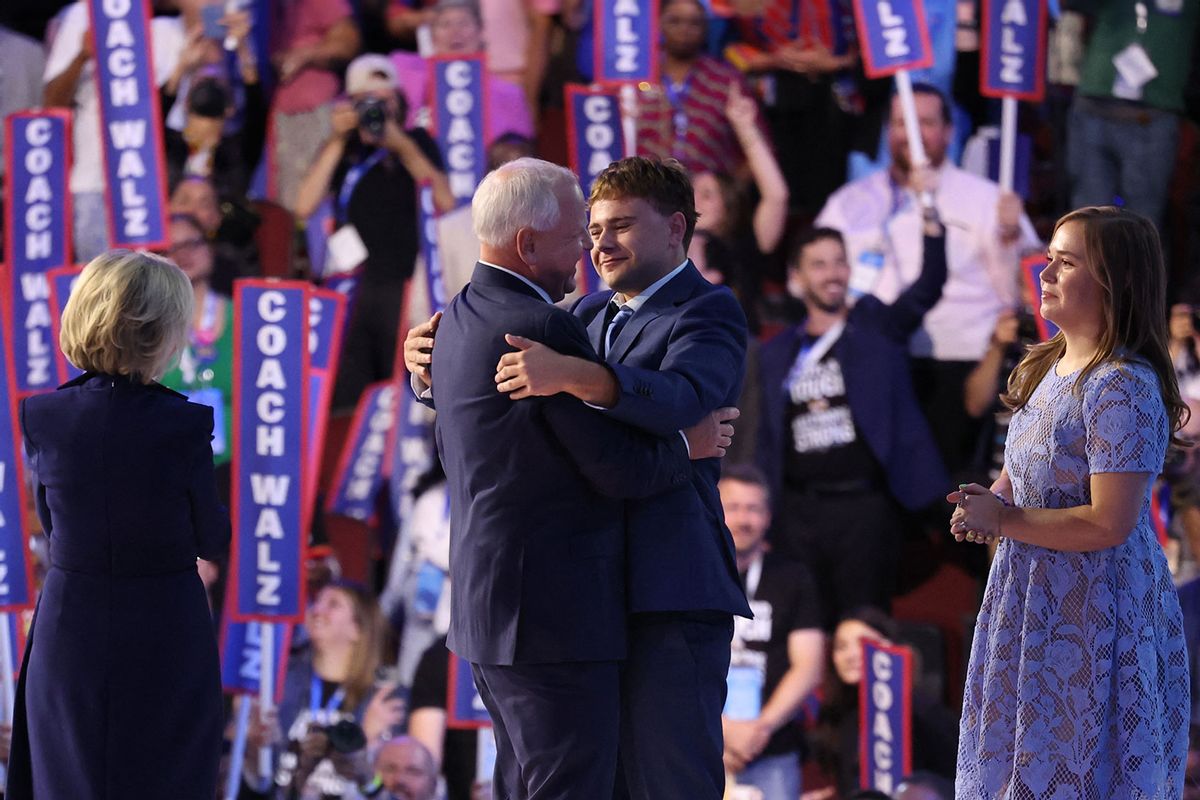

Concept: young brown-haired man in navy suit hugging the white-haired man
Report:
left=496, top=158, right=750, bottom=800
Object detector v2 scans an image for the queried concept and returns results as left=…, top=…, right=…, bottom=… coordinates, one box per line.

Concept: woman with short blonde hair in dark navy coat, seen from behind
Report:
left=5, top=251, right=229, bottom=800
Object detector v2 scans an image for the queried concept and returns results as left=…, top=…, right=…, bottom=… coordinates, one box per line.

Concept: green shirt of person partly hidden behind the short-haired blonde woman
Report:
left=160, top=293, right=233, bottom=464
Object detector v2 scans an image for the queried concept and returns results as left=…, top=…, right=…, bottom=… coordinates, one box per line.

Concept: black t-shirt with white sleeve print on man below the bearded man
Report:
left=733, top=553, right=821, bottom=756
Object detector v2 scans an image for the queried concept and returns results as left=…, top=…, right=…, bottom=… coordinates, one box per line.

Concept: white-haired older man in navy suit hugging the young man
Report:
left=412, top=158, right=731, bottom=800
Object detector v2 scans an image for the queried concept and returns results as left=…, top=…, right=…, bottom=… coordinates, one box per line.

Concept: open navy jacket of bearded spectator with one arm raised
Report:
left=757, top=236, right=949, bottom=519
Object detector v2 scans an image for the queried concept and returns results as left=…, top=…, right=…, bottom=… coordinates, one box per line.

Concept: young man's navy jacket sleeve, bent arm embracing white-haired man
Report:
left=606, top=290, right=746, bottom=437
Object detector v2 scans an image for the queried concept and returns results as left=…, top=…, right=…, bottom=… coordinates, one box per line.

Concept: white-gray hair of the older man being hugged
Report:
left=470, top=157, right=583, bottom=247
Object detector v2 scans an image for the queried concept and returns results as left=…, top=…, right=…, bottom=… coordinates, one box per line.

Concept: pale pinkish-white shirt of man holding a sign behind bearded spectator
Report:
left=815, top=164, right=1042, bottom=361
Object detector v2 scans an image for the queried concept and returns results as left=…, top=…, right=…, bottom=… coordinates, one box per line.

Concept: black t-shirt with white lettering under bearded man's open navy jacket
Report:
left=784, top=333, right=880, bottom=488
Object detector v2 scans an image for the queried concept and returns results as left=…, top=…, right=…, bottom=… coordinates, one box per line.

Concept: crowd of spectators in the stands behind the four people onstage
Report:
left=0, top=0, right=1200, bottom=800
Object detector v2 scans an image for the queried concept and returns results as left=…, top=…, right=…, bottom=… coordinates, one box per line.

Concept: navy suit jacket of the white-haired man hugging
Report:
left=433, top=264, right=691, bottom=664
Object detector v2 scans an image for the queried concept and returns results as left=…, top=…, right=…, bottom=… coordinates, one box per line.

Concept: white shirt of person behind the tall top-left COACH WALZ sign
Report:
left=42, top=0, right=185, bottom=193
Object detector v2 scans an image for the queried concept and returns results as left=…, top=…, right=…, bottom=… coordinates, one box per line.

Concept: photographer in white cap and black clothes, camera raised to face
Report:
left=295, top=54, right=455, bottom=409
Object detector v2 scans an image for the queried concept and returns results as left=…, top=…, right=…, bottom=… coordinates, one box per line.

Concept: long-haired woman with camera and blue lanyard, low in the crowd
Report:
left=239, top=581, right=404, bottom=800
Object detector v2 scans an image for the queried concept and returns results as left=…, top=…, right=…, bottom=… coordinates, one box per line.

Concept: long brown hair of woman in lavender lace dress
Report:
left=1000, top=205, right=1188, bottom=444
